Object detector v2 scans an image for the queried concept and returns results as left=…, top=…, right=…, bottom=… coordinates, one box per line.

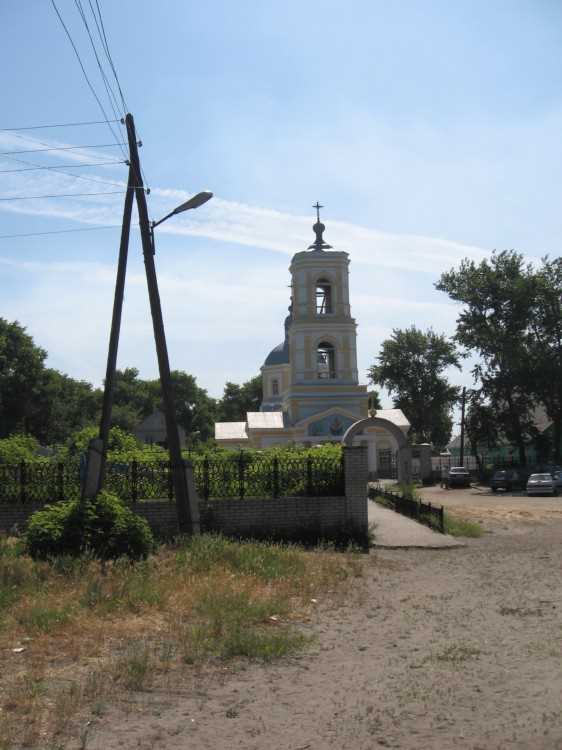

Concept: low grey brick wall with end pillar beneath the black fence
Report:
left=0, top=446, right=368, bottom=542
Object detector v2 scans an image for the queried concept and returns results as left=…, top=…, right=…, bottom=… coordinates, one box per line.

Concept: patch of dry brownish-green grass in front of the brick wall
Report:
left=0, top=535, right=363, bottom=750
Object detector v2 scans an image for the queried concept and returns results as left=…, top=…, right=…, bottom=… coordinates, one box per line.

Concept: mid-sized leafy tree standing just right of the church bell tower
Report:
left=369, top=326, right=460, bottom=447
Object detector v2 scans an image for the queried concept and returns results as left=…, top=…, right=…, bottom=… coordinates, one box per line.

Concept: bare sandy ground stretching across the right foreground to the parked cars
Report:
left=64, top=490, right=562, bottom=750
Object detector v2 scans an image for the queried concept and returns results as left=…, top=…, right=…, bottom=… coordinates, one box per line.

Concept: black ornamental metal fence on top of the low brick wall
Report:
left=0, top=452, right=345, bottom=504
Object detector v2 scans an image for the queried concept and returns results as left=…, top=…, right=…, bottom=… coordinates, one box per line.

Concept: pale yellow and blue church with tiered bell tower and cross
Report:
left=215, top=203, right=410, bottom=465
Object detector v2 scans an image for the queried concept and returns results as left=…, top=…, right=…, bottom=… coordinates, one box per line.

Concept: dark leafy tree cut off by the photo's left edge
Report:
left=0, top=318, right=47, bottom=437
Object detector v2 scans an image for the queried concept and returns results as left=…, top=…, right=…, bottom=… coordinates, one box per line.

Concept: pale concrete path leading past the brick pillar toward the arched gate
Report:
left=369, top=500, right=465, bottom=549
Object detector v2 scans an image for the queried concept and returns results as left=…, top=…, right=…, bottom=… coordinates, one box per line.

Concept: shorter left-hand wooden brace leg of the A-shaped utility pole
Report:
left=82, top=165, right=135, bottom=506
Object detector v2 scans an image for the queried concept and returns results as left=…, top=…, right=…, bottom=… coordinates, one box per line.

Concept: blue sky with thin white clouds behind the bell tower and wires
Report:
left=0, top=0, right=562, bottom=408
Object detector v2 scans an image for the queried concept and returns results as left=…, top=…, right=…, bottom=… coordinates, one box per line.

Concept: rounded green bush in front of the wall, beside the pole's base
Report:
left=25, top=492, right=154, bottom=560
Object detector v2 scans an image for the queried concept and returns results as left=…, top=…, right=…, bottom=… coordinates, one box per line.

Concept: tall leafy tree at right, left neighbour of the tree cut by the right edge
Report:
left=436, top=251, right=536, bottom=464
